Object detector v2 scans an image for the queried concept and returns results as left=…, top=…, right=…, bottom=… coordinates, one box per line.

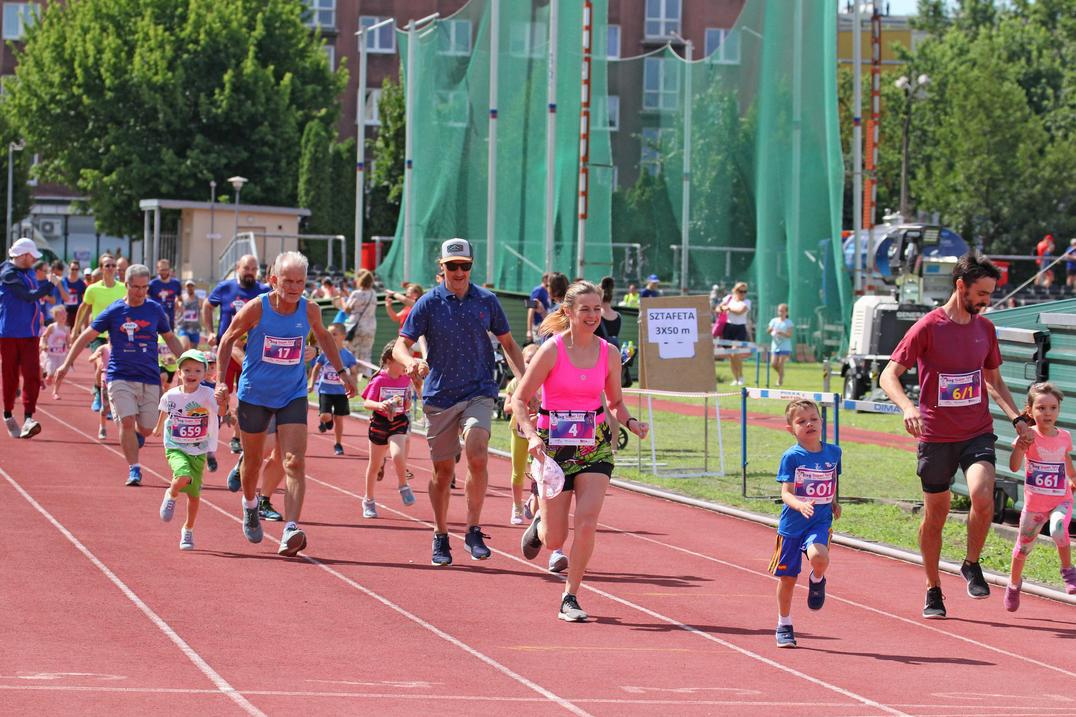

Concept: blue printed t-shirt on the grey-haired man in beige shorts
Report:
left=90, top=299, right=172, bottom=384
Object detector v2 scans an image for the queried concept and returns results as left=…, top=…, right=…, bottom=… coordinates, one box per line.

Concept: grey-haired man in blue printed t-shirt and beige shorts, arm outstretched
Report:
left=56, top=264, right=183, bottom=486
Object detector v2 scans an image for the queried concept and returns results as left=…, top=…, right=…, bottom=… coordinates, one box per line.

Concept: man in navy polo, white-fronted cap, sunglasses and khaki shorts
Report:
left=393, top=239, right=523, bottom=565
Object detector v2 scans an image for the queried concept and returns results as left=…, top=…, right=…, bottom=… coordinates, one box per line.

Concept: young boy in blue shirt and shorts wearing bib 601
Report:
left=769, top=398, right=840, bottom=647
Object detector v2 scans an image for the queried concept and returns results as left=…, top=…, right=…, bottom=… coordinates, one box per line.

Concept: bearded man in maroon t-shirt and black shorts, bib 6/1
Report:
left=879, top=252, right=1033, bottom=618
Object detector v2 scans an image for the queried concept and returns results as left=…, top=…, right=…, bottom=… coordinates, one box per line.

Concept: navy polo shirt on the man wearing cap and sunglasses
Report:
left=400, top=283, right=511, bottom=408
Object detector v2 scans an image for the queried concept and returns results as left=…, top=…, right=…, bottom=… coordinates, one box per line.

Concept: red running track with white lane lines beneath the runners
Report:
left=0, top=377, right=1076, bottom=717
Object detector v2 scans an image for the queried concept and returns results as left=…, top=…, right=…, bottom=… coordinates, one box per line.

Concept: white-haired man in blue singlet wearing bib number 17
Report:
left=216, top=252, right=357, bottom=557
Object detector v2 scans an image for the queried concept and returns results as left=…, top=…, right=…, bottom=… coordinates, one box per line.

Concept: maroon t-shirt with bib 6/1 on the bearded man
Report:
left=890, top=309, right=1002, bottom=444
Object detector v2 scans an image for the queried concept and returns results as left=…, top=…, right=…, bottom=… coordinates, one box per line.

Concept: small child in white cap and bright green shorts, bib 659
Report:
left=153, top=349, right=221, bottom=550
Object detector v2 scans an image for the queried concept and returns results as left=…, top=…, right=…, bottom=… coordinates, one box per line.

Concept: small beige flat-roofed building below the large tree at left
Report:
left=131, top=199, right=310, bottom=283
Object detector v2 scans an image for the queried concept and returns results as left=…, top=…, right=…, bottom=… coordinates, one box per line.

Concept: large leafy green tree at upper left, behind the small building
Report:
left=5, top=0, right=346, bottom=235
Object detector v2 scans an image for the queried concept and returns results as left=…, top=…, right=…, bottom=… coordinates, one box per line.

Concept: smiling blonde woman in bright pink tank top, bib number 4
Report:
left=512, top=281, right=650, bottom=622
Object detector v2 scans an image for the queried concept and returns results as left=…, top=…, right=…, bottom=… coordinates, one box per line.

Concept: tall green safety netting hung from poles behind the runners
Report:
left=379, top=0, right=851, bottom=341
